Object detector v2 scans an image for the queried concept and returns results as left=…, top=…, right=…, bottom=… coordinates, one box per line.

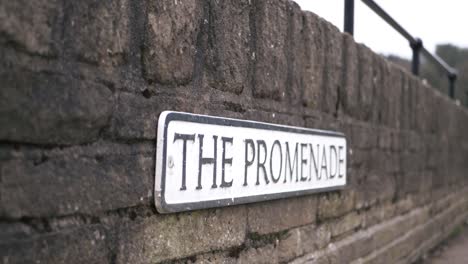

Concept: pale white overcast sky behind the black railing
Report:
left=294, top=0, right=468, bottom=59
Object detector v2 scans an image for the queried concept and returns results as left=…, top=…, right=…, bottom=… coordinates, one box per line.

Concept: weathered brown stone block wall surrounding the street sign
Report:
left=0, top=0, right=468, bottom=263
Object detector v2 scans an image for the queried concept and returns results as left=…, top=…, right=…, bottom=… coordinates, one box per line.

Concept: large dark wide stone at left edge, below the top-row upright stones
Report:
left=0, top=69, right=113, bottom=145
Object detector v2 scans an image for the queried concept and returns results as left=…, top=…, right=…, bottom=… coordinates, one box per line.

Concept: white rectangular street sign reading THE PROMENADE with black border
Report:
left=155, top=111, right=347, bottom=213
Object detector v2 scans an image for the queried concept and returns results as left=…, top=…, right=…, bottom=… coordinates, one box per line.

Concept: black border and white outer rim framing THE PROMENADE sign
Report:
left=154, top=111, right=347, bottom=213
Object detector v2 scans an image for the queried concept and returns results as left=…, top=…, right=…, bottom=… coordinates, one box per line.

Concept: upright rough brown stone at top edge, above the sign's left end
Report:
left=143, top=0, right=202, bottom=84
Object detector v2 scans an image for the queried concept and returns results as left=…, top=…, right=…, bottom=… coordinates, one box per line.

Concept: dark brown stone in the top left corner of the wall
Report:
left=0, top=0, right=60, bottom=56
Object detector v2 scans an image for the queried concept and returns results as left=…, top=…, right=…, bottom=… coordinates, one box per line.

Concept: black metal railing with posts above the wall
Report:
left=344, top=0, right=457, bottom=98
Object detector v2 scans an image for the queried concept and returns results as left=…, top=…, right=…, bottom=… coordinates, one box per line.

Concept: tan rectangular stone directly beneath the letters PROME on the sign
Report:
left=247, top=196, right=317, bottom=234
